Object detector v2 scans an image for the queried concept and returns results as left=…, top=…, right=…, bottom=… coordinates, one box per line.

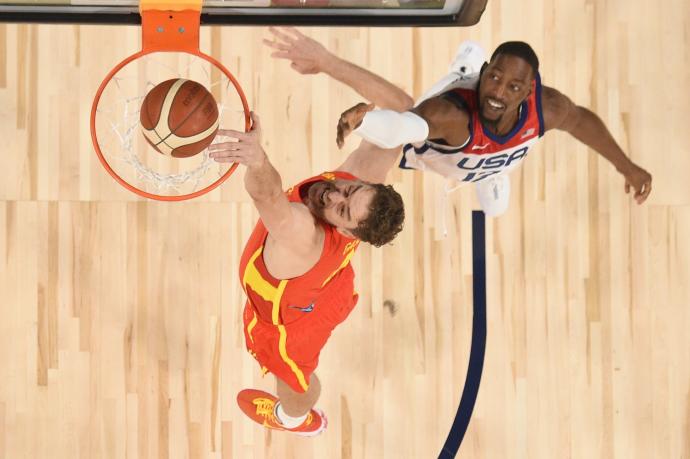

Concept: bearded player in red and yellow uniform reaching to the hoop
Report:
left=209, top=98, right=408, bottom=436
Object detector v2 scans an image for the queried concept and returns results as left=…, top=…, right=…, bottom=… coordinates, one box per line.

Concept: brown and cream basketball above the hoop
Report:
left=139, top=78, right=218, bottom=158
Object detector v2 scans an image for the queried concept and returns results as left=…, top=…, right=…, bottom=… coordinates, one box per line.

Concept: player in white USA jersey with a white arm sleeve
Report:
left=265, top=28, right=652, bottom=216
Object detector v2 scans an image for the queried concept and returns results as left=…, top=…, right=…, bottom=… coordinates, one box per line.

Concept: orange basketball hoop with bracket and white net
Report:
left=90, top=0, right=251, bottom=201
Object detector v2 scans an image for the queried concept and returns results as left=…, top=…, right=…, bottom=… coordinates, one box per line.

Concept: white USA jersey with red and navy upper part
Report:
left=400, top=73, right=544, bottom=183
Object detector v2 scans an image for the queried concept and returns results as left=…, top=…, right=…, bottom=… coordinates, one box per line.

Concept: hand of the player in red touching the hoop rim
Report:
left=208, top=112, right=266, bottom=167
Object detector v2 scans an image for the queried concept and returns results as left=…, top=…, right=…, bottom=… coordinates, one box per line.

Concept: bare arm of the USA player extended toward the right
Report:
left=542, top=86, right=652, bottom=204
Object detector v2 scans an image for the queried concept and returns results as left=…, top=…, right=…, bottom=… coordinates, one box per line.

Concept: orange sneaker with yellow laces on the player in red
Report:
left=237, top=389, right=328, bottom=437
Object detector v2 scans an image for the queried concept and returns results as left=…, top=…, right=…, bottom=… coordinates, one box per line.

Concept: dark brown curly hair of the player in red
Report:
left=352, top=183, right=405, bottom=247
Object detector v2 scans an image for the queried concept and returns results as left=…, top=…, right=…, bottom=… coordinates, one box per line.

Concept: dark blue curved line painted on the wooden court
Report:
left=438, top=210, right=486, bottom=459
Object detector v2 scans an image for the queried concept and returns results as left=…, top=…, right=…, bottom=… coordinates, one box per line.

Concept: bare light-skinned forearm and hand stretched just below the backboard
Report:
left=264, top=27, right=414, bottom=111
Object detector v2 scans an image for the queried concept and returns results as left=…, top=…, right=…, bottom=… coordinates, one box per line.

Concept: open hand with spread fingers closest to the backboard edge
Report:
left=263, top=27, right=335, bottom=74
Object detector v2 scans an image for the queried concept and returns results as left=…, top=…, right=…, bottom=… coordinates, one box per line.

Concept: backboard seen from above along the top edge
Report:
left=0, top=0, right=487, bottom=27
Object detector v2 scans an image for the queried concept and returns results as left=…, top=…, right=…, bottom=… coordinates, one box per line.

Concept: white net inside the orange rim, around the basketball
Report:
left=95, top=52, right=244, bottom=196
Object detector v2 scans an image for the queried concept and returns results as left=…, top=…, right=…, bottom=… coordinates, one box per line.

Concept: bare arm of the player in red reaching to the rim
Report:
left=209, top=112, right=316, bottom=246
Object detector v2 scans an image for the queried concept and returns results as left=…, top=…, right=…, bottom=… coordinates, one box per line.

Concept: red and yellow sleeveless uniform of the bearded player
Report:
left=239, top=171, right=359, bottom=392
